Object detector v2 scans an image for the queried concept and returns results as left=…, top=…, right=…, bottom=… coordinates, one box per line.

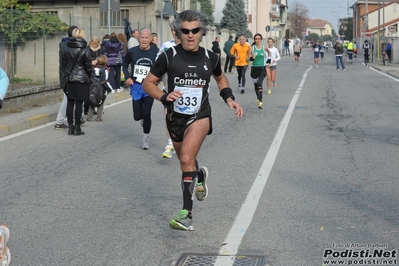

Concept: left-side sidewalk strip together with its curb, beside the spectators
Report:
left=0, top=89, right=131, bottom=138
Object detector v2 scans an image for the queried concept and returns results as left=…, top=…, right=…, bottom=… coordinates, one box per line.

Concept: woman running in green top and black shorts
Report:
left=249, top=33, right=270, bottom=109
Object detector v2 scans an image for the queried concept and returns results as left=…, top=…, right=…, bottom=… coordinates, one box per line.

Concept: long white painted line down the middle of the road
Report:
left=214, top=66, right=312, bottom=266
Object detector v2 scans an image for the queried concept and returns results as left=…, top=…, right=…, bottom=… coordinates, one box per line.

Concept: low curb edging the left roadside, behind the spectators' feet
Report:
left=0, top=90, right=130, bottom=138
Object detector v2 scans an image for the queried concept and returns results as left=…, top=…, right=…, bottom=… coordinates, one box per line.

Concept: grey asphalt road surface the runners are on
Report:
left=0, top=49, right=399, bottom=266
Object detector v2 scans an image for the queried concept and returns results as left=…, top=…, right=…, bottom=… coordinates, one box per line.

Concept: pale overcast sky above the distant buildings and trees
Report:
left=215, top=0, right=355, bottom=29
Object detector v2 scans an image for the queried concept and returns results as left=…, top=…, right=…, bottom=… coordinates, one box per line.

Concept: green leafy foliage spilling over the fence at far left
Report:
left=0, top=0, right=68, bottom=74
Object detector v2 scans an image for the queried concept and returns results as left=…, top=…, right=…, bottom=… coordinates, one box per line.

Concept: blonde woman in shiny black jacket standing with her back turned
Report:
left=62, top=28, right=92, bottom=135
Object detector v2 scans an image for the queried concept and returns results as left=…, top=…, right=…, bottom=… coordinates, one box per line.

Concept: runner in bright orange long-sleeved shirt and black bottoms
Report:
left=230, top=36, right=251, bottom=93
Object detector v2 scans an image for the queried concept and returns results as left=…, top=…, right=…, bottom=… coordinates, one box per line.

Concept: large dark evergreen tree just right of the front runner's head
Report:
left=220, top=0, right=251, bottom=37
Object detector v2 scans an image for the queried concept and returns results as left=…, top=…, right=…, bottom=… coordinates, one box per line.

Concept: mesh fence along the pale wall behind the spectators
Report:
left=0, top=10, right=153, bottom=90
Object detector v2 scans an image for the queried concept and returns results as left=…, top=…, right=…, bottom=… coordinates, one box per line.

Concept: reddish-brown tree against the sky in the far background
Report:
left=288, top=1, right=309, bottom=37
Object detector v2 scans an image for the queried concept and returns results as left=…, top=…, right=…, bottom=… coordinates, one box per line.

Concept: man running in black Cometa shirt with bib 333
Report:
left=143, top=10, right=243, bottom=230
